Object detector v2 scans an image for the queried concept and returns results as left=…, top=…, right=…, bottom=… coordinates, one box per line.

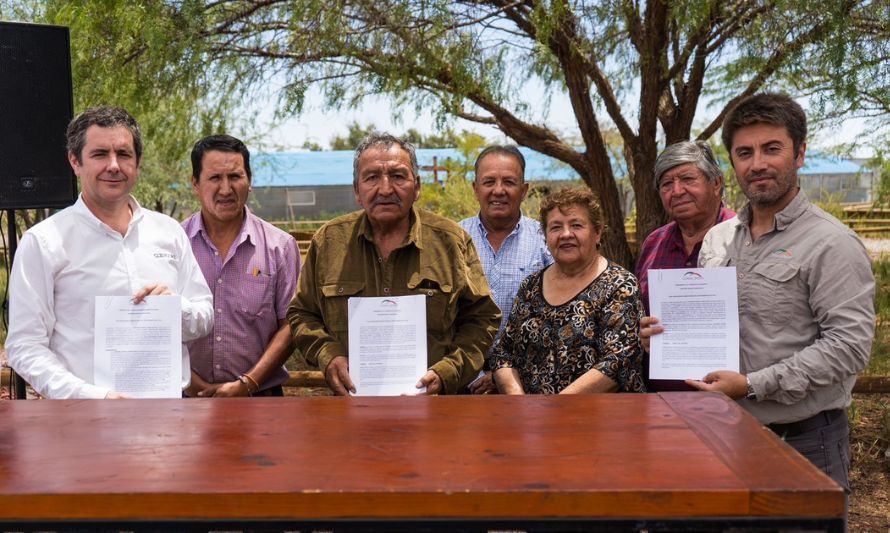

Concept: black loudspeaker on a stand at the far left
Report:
left=0, top=22, right=77, bottom=209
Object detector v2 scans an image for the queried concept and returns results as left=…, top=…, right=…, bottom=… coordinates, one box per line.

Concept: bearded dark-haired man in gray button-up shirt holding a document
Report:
left=688, top=93, right=875, bottom=490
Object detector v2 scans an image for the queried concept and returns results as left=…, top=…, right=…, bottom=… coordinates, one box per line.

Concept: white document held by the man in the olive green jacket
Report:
left=348, top=295, right=427, bottom=396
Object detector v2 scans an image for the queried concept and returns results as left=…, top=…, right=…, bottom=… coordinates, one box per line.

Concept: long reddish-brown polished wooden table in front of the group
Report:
left=0, top=393, right=844, bottom=531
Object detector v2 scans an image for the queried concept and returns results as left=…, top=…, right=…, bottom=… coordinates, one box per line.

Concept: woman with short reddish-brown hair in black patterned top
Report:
left=492, top=188, right=645, bottom=394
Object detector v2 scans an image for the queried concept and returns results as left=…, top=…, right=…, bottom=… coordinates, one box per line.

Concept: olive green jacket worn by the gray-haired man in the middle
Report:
left=287, top=208, right=501, bottom=394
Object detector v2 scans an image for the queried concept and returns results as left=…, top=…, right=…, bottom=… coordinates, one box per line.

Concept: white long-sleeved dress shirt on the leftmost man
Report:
left=6, top=193, right=213, bottom=398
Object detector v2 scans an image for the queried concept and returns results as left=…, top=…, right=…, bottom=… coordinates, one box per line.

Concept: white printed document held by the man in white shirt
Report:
left=93, top=295, right=182, bottom=398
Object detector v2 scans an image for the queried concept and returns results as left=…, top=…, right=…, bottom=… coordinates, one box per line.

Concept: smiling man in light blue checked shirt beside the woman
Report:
left=460, top=145, right=553, bottom=394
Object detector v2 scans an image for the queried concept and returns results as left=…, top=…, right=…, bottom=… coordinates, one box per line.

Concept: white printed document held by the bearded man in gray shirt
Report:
left=649, top=267, right=739, bottom=379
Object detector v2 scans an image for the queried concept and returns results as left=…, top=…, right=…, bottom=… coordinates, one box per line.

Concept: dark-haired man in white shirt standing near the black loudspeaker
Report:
left=6, top=107, right=213, bottom=398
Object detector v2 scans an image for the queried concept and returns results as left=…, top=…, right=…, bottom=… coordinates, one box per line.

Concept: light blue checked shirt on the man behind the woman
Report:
left=460, top=215, right=553, bottom=334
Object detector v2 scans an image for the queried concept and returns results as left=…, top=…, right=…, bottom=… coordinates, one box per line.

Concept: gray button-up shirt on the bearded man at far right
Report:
left=699, top=191, right=875, bottom=424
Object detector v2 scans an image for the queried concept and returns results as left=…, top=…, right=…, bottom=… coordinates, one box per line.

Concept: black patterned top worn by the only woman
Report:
left=491, top=261, right=646, bottom=394
